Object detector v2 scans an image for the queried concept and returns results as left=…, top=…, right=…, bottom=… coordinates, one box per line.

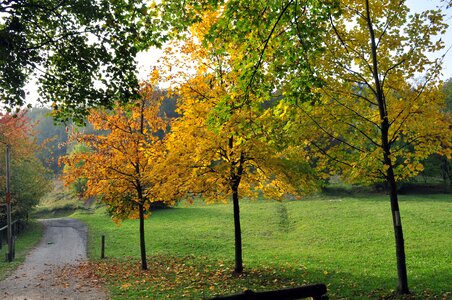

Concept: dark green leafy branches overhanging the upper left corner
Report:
left=0, top=0, right=166, bottom=122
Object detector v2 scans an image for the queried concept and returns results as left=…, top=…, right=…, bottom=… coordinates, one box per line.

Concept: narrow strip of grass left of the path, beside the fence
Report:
left=0, top=221, right=44, bottom=280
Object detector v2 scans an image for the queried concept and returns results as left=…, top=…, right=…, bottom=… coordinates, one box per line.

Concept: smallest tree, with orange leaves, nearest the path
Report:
left=62, top=74, right=169, bottom=270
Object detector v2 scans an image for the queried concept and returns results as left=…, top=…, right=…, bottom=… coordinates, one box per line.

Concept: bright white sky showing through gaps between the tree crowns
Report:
left=26, top=0, right=452, bottom=104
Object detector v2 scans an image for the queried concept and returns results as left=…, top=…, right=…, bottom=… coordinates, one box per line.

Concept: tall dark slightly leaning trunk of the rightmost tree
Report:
left=365, top=0, right=410, bottom=294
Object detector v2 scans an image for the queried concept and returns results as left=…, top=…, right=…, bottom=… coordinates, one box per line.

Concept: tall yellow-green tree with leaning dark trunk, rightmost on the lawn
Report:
left=282, top=0, right=451, bottom=294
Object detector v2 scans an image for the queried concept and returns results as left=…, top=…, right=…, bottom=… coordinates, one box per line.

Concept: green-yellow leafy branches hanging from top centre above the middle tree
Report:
left=207, top=0, right=337, bottom=107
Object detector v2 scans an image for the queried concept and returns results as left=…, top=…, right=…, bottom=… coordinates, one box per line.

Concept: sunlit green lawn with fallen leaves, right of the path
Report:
left=74, top=194, right=452, bottom=299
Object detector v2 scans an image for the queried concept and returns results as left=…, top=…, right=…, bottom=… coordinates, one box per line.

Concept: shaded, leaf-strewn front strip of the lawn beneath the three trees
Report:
left=86, top=256, right=452, bottom=299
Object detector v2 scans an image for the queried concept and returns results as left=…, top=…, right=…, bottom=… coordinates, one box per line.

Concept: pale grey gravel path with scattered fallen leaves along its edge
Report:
left=0, top=219, right=108, bottom=300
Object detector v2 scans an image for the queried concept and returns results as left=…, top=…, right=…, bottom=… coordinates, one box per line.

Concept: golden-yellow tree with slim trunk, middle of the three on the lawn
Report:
left=164, top=12, right=315, bottom=273
